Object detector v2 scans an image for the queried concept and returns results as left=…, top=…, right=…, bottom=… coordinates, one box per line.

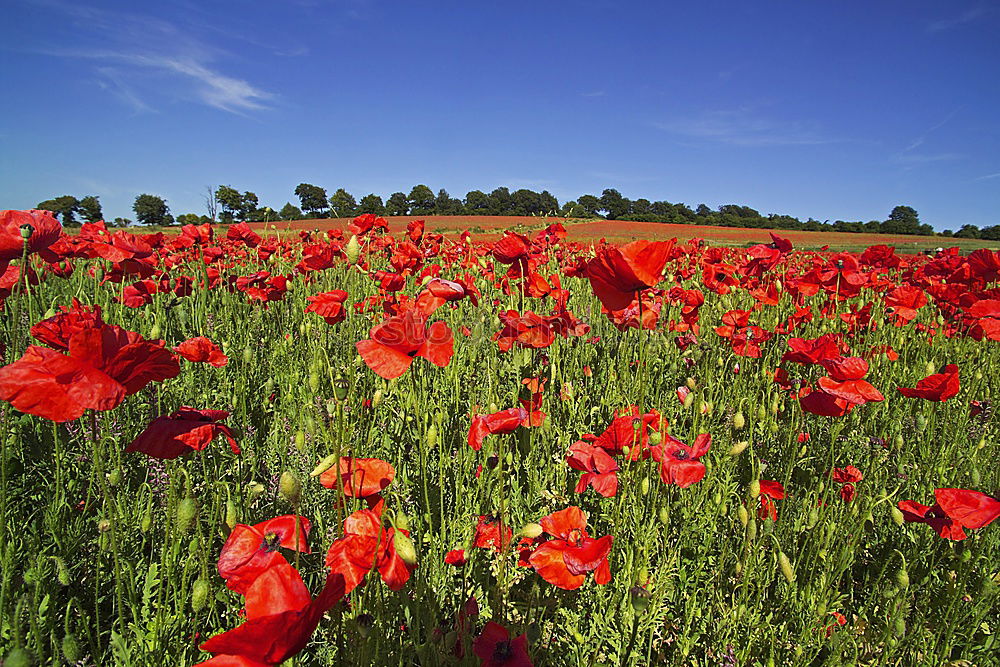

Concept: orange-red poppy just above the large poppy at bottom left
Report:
left=218, top=514, right=311, bottom=595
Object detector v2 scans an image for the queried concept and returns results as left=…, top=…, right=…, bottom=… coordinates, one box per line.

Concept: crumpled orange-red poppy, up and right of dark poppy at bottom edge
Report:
left=528, top=506, right=614, bottom=591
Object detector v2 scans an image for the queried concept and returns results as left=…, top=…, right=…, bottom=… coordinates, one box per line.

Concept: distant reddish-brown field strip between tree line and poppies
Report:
left=244, top=215, right=1000, bottom=253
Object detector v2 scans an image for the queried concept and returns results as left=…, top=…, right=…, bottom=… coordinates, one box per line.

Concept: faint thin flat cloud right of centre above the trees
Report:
left=653, top=109, right=840, bottom=147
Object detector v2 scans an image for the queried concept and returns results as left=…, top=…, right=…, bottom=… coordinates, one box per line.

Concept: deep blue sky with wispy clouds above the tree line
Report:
left=0, top=0, right=1000, bottom=229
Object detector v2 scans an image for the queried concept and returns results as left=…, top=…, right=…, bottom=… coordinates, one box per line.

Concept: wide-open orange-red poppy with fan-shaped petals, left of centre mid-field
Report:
left=356, top=310, right=454, bottom=380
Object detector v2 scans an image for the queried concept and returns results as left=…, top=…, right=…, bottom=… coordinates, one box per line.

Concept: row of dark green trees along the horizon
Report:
left=38, top=183, right=1000, bottom=240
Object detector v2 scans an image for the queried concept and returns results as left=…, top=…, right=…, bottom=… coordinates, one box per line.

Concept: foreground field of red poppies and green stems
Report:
left=0, top=211, right=1000, bottom=667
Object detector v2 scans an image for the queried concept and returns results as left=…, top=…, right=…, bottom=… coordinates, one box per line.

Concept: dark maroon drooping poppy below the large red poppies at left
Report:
left=125, top=406, right=240, bottom=459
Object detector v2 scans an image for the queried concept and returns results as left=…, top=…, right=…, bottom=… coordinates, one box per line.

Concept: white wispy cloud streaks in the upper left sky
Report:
left=20, top=0, right=274, bottom=114
